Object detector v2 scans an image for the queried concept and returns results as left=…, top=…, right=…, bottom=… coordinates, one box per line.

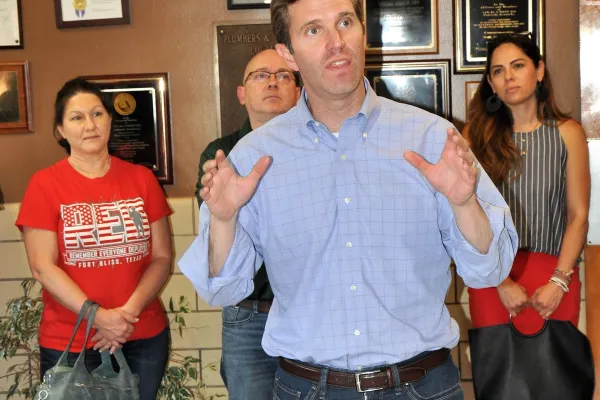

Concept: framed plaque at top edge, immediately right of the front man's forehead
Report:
left=364, top=0, right=438, bottom=54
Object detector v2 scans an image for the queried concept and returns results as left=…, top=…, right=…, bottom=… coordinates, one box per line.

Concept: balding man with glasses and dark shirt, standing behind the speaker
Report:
left=196, top=50, right=300, bottom=400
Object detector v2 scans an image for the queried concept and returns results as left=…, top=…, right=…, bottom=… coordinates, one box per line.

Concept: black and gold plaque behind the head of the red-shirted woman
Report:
left=82, top=72, right=173, bottom=184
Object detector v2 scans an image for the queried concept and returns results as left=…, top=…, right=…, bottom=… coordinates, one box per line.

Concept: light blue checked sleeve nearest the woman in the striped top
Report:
left=437, top=167, right=519, bottom=289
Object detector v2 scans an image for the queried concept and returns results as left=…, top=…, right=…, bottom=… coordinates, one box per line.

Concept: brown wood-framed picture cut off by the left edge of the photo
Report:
left=0, top=61, right=33, bottom=134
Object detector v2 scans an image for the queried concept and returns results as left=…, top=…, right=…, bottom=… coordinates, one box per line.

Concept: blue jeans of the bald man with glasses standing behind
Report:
left=221, top=306, right=279, bottom=400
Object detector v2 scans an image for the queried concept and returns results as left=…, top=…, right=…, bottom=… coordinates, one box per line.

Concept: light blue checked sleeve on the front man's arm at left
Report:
left=178, top=153, right=263, bottom=306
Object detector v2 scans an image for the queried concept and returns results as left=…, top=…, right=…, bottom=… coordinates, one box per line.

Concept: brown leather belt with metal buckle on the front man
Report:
left=279, top=348, right=450, bottom=392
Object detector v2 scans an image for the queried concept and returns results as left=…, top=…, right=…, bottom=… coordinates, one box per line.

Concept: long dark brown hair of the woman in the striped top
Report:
left=467, top=34, right=569, bottom=184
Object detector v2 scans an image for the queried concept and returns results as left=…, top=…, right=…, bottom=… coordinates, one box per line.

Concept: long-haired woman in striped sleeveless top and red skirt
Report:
left=463, top=34, right=590, bottom=364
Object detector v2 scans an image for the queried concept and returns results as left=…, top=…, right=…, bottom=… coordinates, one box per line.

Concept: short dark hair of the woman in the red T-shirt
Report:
left=53, top=78, right=113, bottom=154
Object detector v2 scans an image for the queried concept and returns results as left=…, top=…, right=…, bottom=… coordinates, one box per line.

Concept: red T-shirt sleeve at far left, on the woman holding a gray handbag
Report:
left=15, top=172, right=60, bottom=232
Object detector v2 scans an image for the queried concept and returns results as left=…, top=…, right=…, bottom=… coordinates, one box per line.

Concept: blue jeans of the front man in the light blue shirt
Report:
left=273, top=353, right=464, bottom=400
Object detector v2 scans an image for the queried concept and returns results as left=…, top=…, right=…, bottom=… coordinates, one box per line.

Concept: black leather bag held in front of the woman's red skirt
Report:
left=469, top=320, right=594, bottom=400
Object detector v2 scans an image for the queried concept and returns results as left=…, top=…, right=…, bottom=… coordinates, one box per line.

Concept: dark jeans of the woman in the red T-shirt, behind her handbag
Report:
left=40, top=327, right=169, bottom=400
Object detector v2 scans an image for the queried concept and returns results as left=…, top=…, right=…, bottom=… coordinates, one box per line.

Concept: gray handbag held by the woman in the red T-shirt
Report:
left=35, top=300, right=140, bottom=400
